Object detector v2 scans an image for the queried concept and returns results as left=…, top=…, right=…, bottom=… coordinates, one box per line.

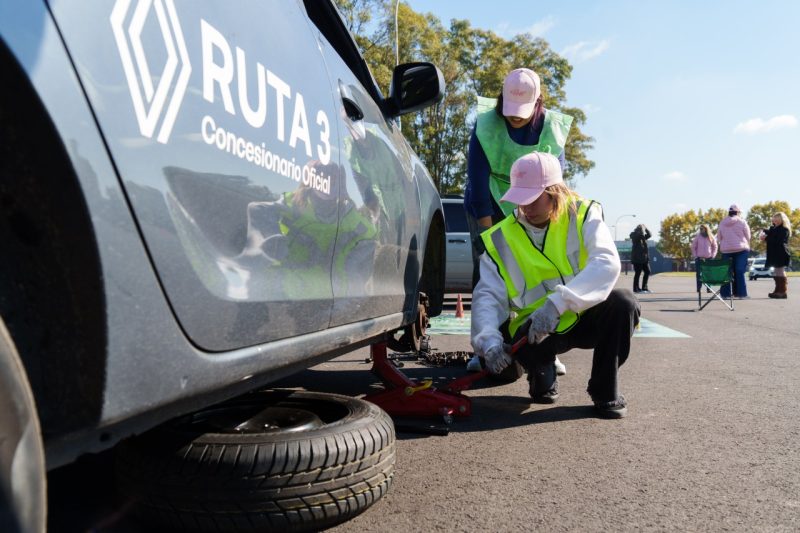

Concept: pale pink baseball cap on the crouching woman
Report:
left=500, top=152, right=564, bottom=205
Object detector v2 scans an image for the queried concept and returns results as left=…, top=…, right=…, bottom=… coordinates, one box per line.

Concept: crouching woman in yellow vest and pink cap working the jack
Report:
left=472, top=152, right=640, bottom=418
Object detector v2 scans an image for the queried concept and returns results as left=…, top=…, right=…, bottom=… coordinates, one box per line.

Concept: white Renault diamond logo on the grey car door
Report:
left=111, top=0, right=192, bottom=143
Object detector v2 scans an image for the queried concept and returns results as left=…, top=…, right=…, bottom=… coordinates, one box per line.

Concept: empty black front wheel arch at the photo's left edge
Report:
left=0, top=41, right=107, bottom=439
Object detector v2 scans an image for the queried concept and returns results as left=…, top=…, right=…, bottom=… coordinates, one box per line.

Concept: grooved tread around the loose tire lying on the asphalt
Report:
left=117, top=388, right=396, bottom=531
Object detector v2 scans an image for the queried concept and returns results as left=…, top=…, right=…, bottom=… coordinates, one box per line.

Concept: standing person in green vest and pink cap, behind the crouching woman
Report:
left=464, top=68, right=572, bottom=376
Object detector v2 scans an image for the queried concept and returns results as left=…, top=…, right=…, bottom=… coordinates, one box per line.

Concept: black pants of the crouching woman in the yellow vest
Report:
left=516, top=289, right=641, bottom=402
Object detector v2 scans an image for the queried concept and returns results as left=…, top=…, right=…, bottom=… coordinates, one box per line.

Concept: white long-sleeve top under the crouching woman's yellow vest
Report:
left=472, top=204, right=620, bottom=355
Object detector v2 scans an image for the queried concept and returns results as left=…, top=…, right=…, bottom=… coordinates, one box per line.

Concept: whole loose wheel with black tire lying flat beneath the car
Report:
left=117, top=391, right=395, bottom=531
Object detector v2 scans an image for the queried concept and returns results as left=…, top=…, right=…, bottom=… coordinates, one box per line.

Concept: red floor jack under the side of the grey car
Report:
left=365, top=337, right=528, bottom=424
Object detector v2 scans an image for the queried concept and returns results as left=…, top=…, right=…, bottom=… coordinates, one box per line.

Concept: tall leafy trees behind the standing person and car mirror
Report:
left=337, top=0, right=594, bottom=194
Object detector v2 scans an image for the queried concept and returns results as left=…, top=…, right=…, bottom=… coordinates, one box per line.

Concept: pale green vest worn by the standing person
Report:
left=475, top=96, right=572, bottom=215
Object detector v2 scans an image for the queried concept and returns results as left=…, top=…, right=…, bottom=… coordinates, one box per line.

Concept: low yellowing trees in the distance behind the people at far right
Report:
left=657, top=200, right=800, bottom=263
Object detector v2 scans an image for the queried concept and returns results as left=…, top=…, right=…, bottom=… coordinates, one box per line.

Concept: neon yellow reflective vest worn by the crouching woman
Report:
left=481, top=196, right=595, bottom=336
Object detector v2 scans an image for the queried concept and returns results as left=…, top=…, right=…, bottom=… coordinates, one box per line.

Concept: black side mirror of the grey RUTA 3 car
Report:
left=384, top=63, right=444, bottom=117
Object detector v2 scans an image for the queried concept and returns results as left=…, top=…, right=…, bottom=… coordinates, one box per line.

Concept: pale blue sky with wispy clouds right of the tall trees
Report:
left=403, top=0, right=800, bottom=240
